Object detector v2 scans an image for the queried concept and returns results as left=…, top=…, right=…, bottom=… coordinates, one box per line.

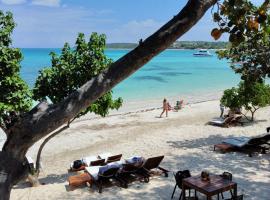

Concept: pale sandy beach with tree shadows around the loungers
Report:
left=7, top=101, right=270, bottom=200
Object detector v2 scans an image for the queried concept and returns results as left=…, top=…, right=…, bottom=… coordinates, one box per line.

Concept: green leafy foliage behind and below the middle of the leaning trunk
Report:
left=33, top=33, right=122, bottom=117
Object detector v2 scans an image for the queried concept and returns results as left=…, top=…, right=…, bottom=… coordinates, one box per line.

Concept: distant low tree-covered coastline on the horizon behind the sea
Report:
left=106, top=41, right=229, bottom=49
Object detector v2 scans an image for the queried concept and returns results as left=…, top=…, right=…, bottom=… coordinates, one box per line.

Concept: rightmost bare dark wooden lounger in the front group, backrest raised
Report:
left=137, top=156, right=169, bottom=182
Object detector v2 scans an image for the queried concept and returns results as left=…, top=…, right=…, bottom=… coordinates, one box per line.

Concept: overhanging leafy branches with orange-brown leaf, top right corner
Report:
left=211, top=0, right=270, bottom=82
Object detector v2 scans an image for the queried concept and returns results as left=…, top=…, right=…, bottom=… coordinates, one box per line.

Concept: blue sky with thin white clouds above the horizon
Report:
left=0, top=0, right=227, bottom=48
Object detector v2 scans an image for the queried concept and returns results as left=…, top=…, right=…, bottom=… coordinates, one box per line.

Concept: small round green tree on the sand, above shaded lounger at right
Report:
left=221, top=81, right=270, bottom=121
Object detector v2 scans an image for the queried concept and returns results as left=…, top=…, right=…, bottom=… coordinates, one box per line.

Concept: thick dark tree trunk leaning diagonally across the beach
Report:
left=0, top=0, right=217, bottom=200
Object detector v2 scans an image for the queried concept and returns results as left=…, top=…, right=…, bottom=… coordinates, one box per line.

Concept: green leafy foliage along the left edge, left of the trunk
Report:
left=0, top=11, right=32, bottom=128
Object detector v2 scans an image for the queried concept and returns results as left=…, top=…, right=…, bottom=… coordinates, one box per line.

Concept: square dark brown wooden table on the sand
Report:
left=182, top=175, right=237, bottom=200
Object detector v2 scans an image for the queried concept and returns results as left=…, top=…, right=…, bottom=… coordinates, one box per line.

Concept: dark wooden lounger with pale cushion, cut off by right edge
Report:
left=214, top=133, right=270, bottom=156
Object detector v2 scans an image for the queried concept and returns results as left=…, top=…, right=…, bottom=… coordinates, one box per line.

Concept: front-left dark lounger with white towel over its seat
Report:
left=85, top=161, right=123, bottom=193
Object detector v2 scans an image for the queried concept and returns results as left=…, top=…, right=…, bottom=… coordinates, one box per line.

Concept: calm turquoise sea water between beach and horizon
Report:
left=21, top=49, right=239, bottom=101
